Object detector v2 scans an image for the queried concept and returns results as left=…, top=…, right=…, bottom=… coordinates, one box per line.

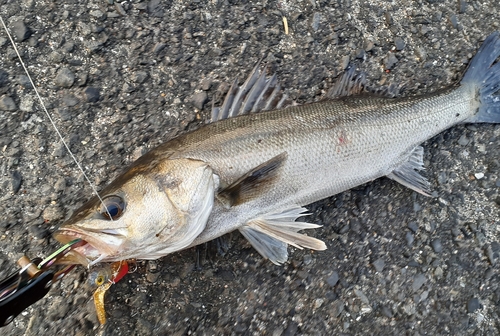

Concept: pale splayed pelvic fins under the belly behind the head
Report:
left=240, top=207, right=326, bottom=265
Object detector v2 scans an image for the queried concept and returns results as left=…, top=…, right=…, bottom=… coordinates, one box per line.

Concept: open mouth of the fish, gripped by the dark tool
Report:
left=53, top=227, right=125, bottom=267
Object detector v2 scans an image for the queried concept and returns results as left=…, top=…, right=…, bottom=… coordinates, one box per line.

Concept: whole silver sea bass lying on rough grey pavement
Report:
left=55, top=32, right=500, bottom=264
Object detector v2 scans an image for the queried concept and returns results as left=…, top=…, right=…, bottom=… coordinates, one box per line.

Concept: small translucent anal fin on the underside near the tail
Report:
left=387, top=146, right=432, bottom=197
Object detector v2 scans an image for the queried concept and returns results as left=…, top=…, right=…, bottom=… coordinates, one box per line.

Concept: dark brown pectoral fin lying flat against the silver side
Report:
left=217, top=152, right=287, bottom=208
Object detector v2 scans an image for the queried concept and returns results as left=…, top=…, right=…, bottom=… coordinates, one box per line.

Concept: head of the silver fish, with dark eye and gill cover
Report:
left=54, top=157, right=218, bottom=265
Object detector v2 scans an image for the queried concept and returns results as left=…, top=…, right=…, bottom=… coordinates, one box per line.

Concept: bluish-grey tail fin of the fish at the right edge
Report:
left=461, top=32, right=500, bottom=123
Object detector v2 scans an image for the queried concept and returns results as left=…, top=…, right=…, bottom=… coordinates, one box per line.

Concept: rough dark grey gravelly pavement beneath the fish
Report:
left=0, top=0, right=500, bottom=335
